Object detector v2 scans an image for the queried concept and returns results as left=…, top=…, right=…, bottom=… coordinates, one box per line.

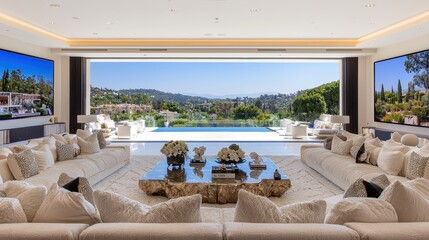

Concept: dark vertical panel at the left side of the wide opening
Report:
left=69, top=57, right=86, bottom=133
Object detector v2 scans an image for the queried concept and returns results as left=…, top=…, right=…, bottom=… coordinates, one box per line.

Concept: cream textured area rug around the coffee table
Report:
left=94, top=155, right=343, bottom=223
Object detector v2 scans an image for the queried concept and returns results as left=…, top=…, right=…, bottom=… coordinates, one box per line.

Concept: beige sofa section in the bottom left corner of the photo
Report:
left=0, top=223, right=88, bottom=240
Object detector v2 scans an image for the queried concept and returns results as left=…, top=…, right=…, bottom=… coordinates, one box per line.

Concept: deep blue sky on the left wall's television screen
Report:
left=0, top=50, right=54, bottom=82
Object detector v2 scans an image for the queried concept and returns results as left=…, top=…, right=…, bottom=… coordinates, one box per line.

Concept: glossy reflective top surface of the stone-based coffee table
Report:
left=140, top=157, right=288, bottom=183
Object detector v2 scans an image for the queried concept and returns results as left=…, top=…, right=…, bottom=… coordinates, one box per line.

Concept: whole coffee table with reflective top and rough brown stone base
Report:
left=139, top=158, right=291, bottom=203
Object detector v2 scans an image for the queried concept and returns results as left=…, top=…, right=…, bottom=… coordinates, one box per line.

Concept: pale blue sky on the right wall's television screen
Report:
left=374, top=56, right=421, bottom=93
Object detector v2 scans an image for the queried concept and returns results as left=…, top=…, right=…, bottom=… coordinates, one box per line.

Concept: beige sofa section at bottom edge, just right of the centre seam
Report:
left=224, top=222, right=359, bottom=240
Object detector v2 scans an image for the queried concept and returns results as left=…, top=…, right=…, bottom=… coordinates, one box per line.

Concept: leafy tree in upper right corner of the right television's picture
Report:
left=404, top=51, right=429, bottom=89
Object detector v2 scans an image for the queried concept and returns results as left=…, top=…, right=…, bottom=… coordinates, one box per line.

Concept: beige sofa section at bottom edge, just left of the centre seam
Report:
left=79, top=223, right=223, bottom=240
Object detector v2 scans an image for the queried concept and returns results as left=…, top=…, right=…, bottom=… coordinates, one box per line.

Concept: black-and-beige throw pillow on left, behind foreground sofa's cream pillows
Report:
left=57, top=173, right=96, bottom=207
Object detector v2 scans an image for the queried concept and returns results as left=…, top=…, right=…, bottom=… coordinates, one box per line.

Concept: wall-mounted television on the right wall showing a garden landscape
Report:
left=374, top=50, right=429, bottom=127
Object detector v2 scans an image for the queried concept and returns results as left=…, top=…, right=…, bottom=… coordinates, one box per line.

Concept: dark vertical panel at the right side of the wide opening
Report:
left=341, top=58, right=359, bottom=133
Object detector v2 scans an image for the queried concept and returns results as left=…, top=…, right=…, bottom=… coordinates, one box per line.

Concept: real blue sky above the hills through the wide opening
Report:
left=90, top=61, right=339, bottom=96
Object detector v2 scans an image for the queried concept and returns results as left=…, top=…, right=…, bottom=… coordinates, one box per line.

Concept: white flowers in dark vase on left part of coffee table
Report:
left=161, top=141, right=189, bottom=168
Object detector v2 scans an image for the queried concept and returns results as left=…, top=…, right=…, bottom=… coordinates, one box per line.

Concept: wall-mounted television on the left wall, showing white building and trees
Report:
left=0, top=49, right=54, bottom=119
